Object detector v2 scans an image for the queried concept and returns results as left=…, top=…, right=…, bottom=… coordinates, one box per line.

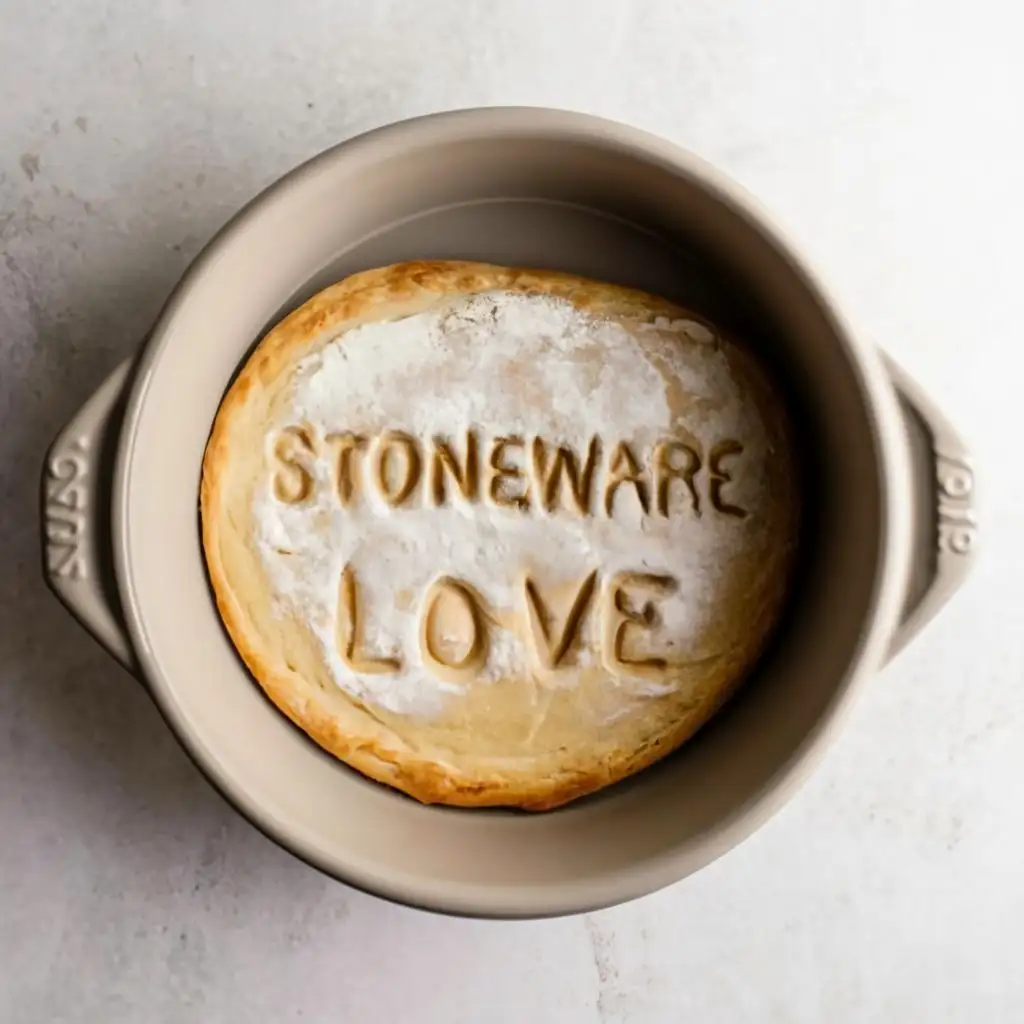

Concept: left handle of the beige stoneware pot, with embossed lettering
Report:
left=41, top=359, right=136, bottom=673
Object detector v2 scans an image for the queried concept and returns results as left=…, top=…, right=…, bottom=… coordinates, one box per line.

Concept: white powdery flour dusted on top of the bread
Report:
left=254, top=292, right=763, bottom=715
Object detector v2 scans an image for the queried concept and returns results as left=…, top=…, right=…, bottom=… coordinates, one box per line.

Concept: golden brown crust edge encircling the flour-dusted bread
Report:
left=201, top=261, right=797, bottom=810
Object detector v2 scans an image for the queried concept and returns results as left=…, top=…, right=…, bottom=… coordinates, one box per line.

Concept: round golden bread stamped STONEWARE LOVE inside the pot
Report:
left=195, top=262, right=799, bottom=810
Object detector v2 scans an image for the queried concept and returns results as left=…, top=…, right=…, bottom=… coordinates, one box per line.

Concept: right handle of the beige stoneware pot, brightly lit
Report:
left=884, top=354, right=978, bottom=658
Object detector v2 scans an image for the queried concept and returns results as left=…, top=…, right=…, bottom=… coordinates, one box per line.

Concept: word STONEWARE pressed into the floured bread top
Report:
left=269, top=425, right=750, bottom=519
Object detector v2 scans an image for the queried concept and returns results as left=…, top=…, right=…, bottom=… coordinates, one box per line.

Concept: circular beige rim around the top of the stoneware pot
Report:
left=112, top=108, right=909, bottom=918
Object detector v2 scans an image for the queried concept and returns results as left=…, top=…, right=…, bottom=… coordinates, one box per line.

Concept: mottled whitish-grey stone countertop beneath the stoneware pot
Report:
left=0, top=0, right=1024, bottom=1024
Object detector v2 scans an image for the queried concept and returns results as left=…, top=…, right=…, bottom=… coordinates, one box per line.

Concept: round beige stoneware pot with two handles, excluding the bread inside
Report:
left=37, top=109, right=976, bottom=916
